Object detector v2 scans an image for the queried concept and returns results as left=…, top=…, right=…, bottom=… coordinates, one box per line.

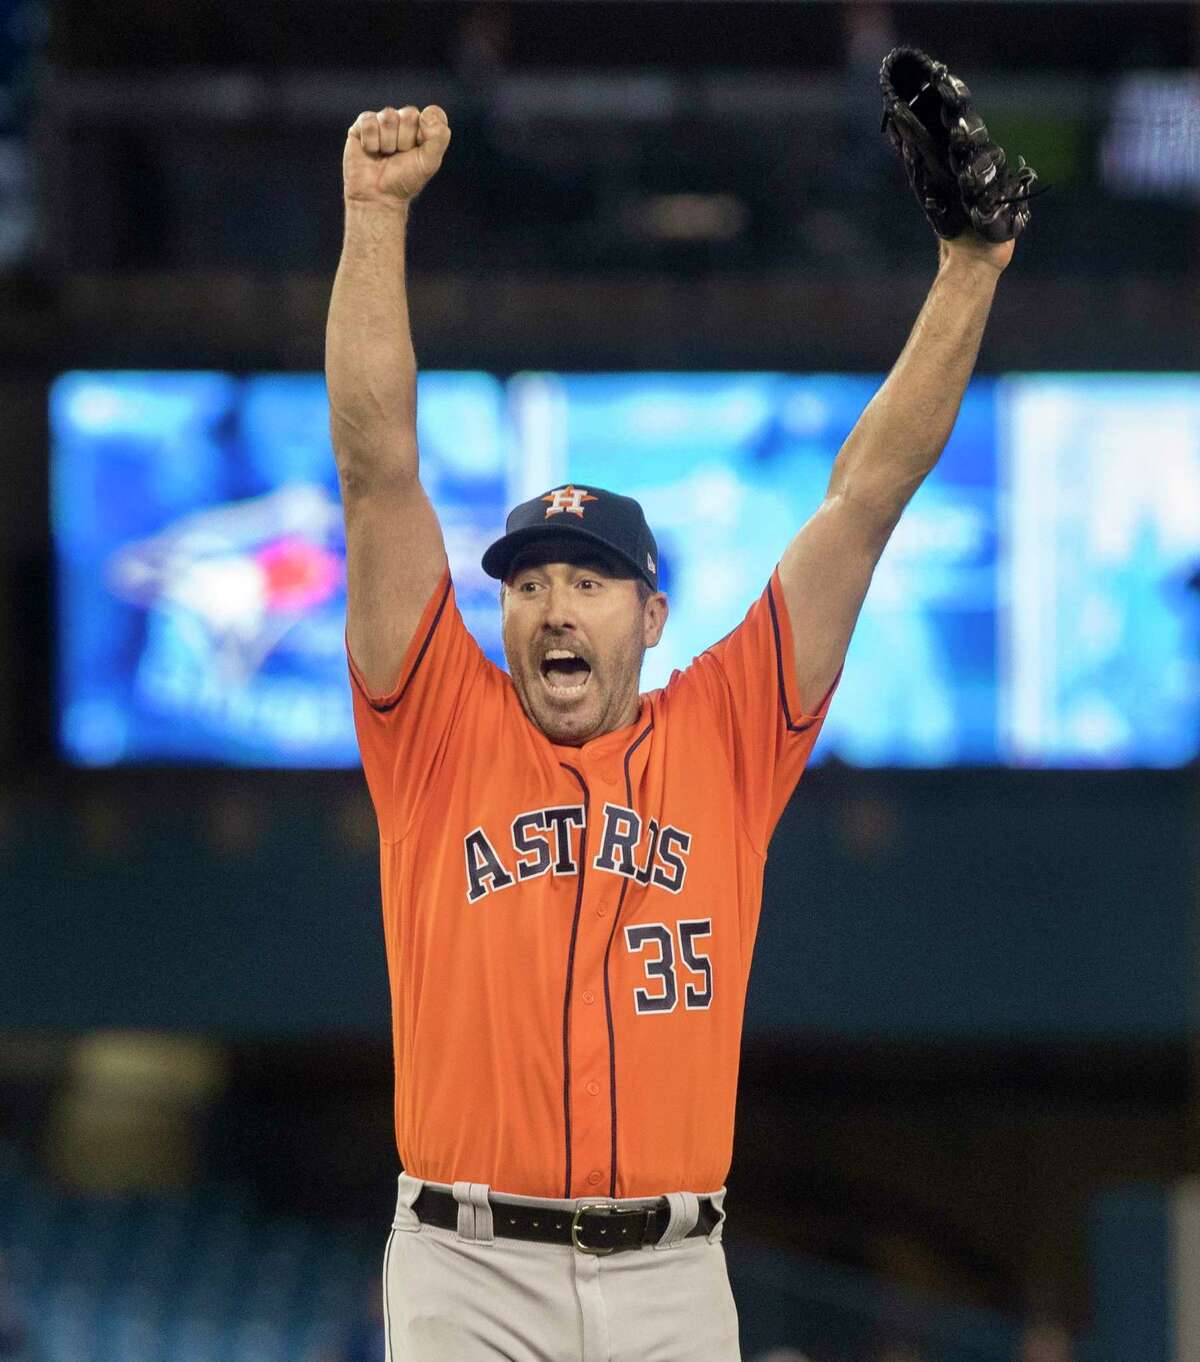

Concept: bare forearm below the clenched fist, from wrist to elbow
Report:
left=326, top=202, right=417, bottom=479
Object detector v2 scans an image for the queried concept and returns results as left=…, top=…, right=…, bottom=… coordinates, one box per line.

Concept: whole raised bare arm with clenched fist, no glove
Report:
left=326, top=105, right=449, bottom=695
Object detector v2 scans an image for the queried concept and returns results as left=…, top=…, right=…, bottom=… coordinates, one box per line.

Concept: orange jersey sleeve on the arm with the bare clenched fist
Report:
left=346, top=569, right=490, bottom=842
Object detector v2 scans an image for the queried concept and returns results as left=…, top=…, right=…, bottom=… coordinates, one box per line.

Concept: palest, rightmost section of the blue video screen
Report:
left=1000, top=375, right=1200, bottom=767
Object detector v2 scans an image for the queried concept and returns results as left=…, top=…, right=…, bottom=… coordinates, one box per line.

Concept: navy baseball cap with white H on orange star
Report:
left=484, top=482, right=658, bottom=591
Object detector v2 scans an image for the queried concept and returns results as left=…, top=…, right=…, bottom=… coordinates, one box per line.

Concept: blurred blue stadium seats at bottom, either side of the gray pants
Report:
left=0, top=1144, right=1091, bottom=1362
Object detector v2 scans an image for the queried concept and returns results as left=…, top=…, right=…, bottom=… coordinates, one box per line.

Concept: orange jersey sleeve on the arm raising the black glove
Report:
left=667, top=568, right=840, bottom=854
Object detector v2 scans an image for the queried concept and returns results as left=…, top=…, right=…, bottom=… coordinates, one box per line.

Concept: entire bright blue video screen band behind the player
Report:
left=50, top=372, right=1200, bottom=767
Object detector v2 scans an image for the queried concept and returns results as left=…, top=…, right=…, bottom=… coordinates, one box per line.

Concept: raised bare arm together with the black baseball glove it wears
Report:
left=779, top=48, right=1038, bottom=710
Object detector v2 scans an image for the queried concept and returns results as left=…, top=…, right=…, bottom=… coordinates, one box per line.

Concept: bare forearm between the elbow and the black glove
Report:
left=830, top=244, right=1000, bottom=538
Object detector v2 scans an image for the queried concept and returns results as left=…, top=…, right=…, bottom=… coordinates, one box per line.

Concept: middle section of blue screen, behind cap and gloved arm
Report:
left=515, top=373, right=997, bottom=765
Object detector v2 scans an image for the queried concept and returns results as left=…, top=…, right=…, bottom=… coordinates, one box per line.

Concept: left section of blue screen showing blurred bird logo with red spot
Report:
left=50, top=372, right=505, bottom=767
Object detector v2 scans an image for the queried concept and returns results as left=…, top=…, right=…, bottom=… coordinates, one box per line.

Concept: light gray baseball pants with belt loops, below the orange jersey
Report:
left=383, top=1173, right=741, bottom=1362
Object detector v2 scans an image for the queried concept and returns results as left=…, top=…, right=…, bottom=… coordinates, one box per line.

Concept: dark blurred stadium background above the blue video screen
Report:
left=0, top=0, right=1200, bottom=370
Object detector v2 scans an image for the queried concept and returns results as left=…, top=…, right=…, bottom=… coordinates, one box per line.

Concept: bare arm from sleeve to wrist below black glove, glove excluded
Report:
left=779, top=233, right=1013, bottom=712
